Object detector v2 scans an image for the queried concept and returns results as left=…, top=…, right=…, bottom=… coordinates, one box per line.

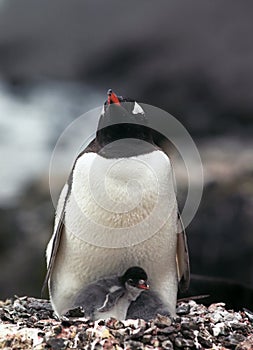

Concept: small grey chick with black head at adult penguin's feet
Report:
left=73, top=266, right=149, bottom=320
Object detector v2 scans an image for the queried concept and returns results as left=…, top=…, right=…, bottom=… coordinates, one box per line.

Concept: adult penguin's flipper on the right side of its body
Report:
left=176, top=214, right=190, bottom=292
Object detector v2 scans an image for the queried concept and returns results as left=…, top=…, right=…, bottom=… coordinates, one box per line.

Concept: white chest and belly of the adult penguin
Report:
left=51, top=151, right=177, bottom=319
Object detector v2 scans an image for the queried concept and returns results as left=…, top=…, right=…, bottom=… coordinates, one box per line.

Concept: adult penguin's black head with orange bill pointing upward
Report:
left=96, top=89, right=153, bottom=147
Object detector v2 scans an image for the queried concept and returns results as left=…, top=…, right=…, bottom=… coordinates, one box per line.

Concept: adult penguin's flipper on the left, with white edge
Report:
left=41, top=184, right=69, bottom=294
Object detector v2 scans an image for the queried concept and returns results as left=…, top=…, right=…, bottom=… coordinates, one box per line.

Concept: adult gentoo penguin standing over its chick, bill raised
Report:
left=44, top=90, right=189, bottom=316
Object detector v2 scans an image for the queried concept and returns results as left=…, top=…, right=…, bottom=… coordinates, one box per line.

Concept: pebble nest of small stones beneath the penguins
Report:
left=0, top=296, right=253, bottom=350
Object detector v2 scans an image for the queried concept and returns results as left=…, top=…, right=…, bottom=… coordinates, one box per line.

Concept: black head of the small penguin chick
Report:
left=121, top=266, right=149, bottom=291
